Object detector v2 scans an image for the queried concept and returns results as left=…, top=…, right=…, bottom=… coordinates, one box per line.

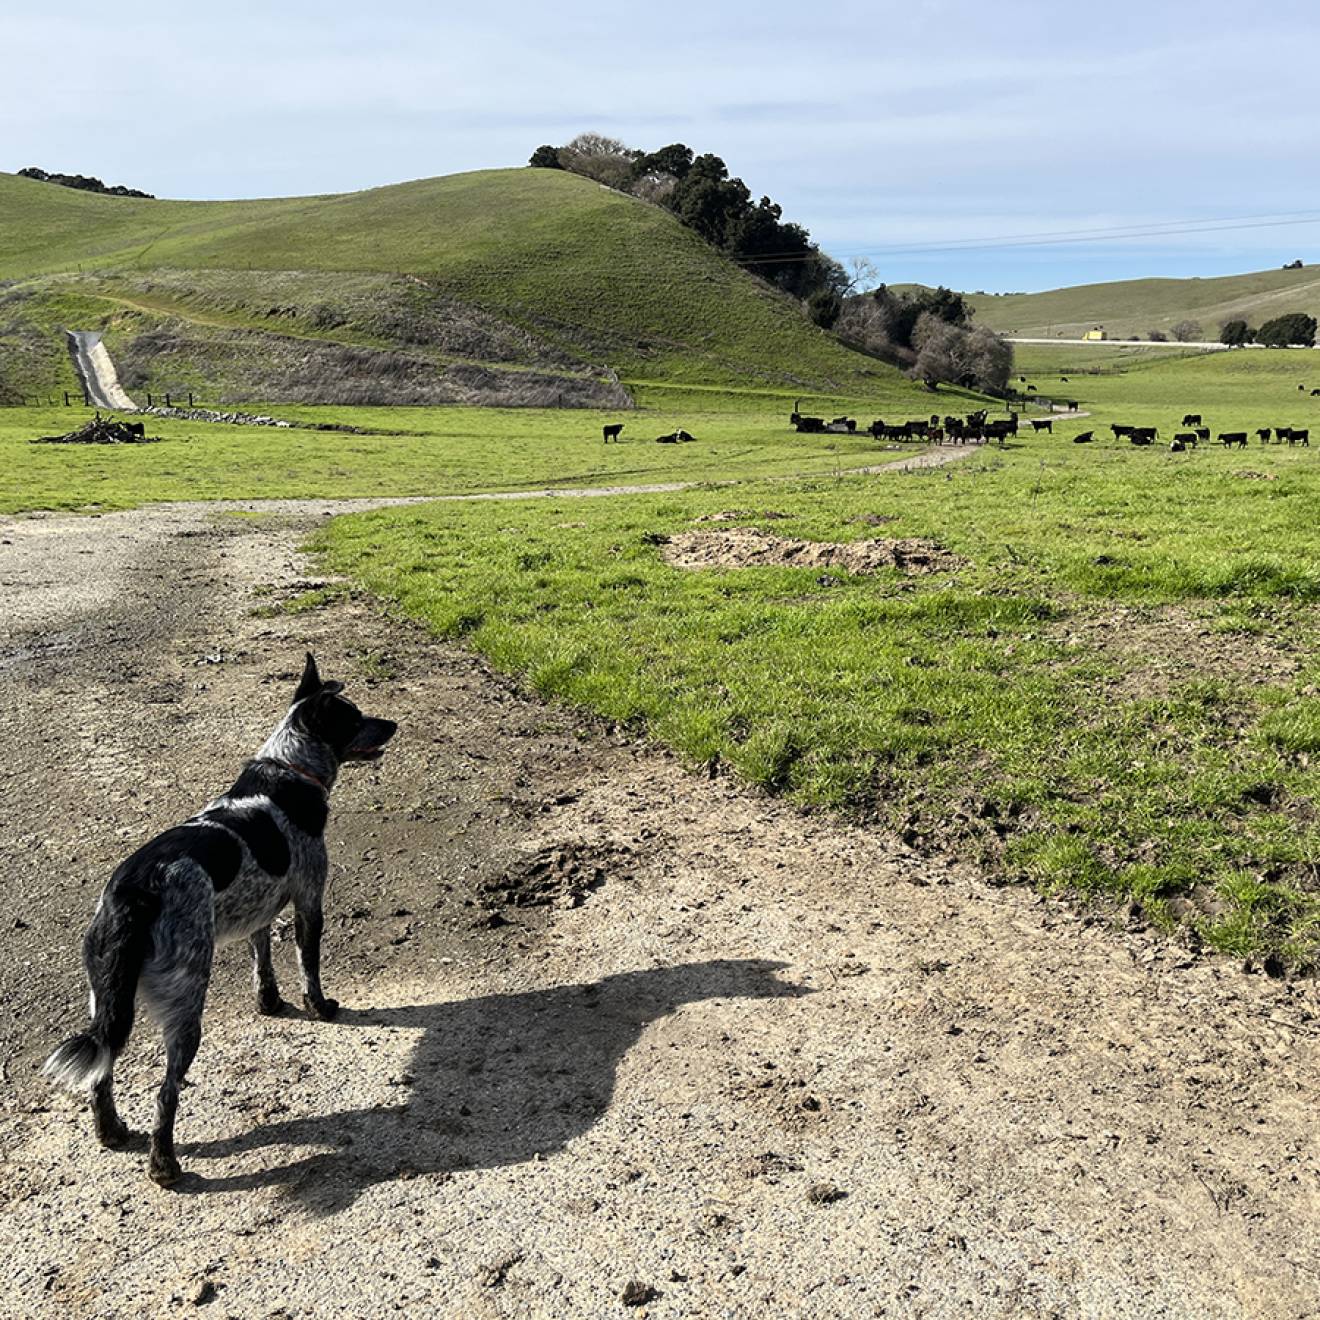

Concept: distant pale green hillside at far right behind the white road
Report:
left=968, top=265, right=1320, bottom=339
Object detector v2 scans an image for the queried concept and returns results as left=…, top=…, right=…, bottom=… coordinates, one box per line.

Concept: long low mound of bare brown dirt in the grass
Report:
left=663, top=527, right=964, bottom=573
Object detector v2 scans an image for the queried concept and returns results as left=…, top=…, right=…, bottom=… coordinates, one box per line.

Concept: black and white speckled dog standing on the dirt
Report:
left=45, top=653, right=397, bottom=1187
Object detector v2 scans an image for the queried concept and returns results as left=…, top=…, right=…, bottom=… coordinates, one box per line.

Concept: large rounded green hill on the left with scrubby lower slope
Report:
left=0, top=169, right=898, bottom=403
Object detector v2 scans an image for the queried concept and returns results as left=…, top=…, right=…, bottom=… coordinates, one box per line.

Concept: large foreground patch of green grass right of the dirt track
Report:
left=317, top=437, right=1320, bottom=965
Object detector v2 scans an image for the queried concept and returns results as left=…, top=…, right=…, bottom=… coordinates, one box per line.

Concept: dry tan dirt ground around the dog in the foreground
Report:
left=0, top=503, right=1320, bottom=1320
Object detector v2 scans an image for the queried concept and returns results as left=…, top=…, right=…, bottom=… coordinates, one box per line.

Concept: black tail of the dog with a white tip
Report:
left=41, top=876, right=160, bottom=1090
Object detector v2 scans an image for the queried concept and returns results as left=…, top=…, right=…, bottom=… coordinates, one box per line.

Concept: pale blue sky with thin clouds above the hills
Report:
left=0, top=0, right=1320, bottom=290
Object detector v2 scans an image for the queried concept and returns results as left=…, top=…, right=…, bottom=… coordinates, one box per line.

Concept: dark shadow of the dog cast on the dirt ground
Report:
left=180, top=960, right=812, bottom=1214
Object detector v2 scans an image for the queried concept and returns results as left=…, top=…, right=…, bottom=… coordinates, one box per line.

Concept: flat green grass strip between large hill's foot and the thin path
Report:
left=0, top=392, right=920, bottom=512
